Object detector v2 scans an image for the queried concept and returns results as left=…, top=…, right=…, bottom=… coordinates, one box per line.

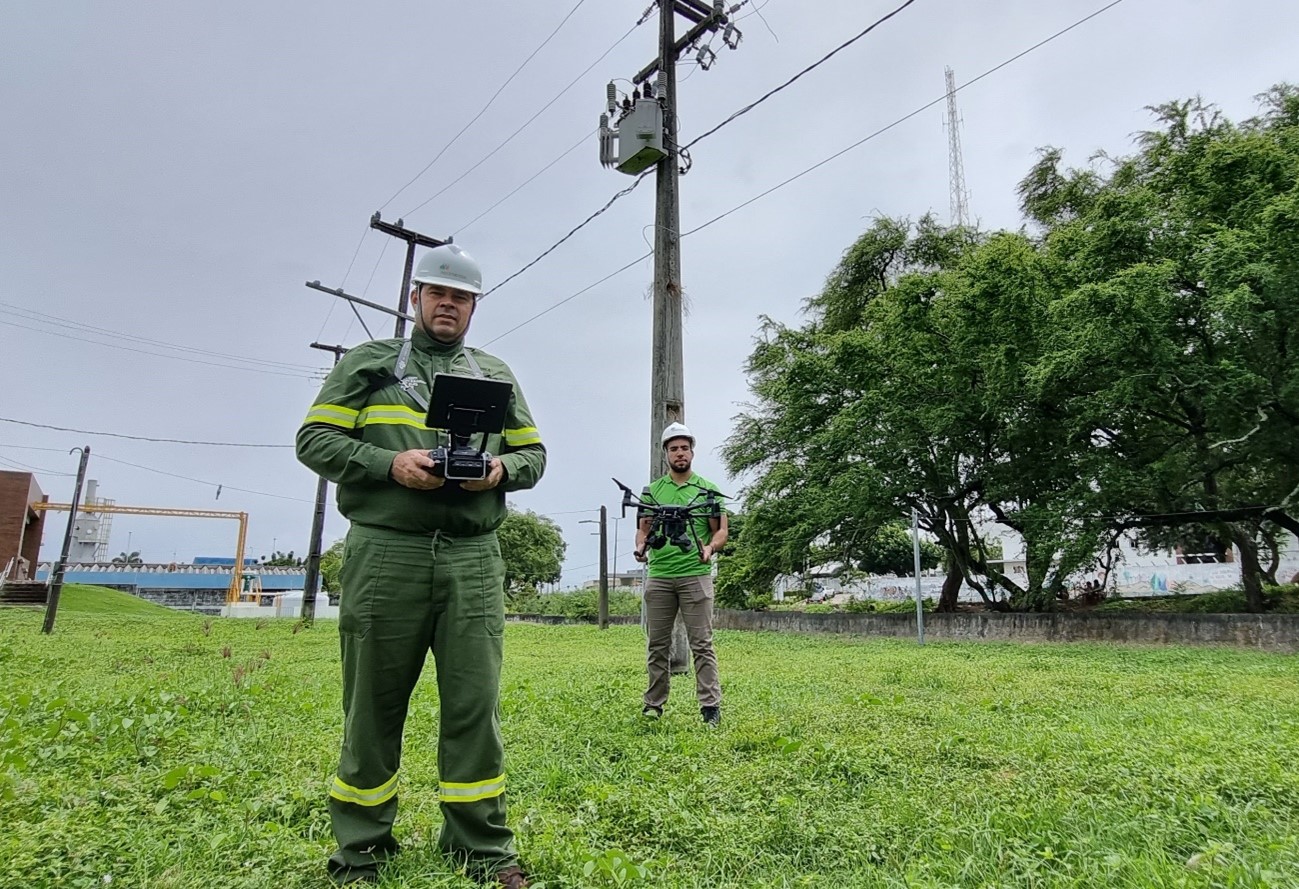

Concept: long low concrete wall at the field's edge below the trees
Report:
left=713, top=610, right=1299, bottom=652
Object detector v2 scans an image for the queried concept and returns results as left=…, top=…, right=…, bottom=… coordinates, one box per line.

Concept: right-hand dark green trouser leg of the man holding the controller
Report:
left=433, top=534, right=516, bottom=870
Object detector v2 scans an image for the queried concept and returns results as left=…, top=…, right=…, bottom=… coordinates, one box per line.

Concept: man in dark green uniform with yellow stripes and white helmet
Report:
left=297, top=244, right=546, bottom=889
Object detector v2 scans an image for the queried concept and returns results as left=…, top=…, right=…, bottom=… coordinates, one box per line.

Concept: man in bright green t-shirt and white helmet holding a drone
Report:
left=635, top=422, right=726, bottom=725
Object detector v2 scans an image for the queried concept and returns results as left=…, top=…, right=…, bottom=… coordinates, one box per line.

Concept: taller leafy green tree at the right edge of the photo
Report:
left=1021, top=86, right=1299, bottom=610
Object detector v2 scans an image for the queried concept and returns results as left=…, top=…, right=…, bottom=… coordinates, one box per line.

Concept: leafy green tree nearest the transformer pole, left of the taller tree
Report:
left=724, top=217, right=1043, bottom=610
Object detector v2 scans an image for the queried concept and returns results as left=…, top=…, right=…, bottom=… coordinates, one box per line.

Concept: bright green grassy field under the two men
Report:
left=0, top=589, right=1299, bottom=889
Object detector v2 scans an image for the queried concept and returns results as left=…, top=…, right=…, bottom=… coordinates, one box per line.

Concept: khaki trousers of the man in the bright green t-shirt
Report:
left=644, top=574, right=722, bottom=708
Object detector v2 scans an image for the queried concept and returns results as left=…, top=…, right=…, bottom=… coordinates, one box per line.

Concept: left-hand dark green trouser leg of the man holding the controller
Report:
left=329, top=528, right=434, bottom=876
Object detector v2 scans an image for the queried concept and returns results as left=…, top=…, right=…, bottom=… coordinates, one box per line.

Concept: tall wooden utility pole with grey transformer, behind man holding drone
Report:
left=600, top=0, right=740, bottom=673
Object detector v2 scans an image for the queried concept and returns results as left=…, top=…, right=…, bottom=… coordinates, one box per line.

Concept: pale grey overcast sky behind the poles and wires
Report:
left=0, top=0, right=1299, bottom=585
